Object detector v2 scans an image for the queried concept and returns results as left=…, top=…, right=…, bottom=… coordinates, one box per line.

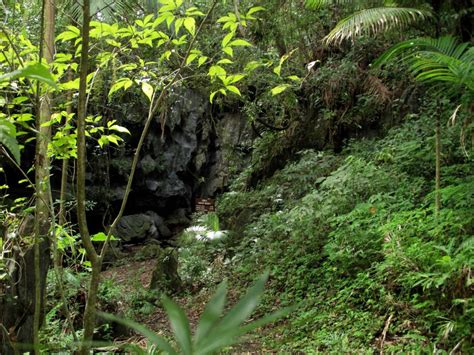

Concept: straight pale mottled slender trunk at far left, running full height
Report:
left=33, top=0, right=54, bottom=354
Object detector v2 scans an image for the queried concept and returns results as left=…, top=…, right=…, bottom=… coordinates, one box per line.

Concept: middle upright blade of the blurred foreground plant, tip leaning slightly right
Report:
left=194, top=281, right=227, bottom=348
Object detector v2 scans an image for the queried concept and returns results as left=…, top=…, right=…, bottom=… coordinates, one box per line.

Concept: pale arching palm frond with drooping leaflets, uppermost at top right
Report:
left=324, top=7, right=431, bottom=44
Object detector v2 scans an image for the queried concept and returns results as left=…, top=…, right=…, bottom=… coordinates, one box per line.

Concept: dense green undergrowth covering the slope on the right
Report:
left=218, top=107, right=474, bottom=353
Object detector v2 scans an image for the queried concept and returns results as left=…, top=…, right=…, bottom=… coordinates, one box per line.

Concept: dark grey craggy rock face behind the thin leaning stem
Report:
left=87, top=89, right=252, bottom=242
